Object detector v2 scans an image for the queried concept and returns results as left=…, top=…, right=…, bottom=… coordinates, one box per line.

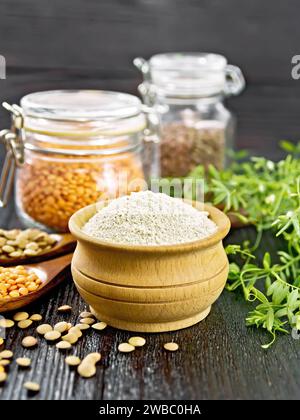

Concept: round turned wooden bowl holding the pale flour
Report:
left=69, top=204, right=230, bottom=332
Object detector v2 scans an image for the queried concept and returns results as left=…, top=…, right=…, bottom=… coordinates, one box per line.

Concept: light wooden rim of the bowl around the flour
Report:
left=69, top=201, right=231, bottom=253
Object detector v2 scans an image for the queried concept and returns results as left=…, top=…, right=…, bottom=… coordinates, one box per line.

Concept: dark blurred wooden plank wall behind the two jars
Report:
left=0, top=0, right=300, bottom=157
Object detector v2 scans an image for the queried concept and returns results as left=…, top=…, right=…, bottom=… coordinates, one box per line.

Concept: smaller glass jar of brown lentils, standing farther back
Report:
left=134, top=53, right=245, bottom=177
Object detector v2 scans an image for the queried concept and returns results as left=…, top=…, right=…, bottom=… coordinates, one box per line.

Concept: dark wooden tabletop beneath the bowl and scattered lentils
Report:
left=0, top=203, right=300, bottom=400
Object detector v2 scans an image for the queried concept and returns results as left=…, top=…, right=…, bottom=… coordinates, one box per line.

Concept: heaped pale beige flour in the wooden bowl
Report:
left=83, top=191, right=217, bottom=245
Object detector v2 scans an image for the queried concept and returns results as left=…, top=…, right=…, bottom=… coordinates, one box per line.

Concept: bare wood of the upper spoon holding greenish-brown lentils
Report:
left=0, top=233, right=76, bottom=267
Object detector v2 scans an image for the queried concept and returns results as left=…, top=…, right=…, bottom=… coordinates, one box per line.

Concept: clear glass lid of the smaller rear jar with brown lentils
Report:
left=134, top=52, right=245, bottom=97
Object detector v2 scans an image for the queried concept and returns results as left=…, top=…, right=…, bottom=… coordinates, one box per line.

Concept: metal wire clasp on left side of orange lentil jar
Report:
left=0, top=102, right=24, bottom=207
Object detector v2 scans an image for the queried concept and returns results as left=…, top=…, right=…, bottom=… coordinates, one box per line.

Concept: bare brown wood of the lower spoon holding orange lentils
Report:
left=0, top=254, right=73, bottom=313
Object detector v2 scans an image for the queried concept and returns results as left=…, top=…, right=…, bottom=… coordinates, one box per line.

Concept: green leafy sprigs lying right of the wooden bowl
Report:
left=189, top=141, right=300, bottom=348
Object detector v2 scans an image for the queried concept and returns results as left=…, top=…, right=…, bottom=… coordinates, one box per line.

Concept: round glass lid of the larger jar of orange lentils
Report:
left=20, top=90, right=146, bottom=138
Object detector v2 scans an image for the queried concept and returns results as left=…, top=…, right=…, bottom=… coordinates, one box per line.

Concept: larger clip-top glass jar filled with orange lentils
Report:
left=0, top=90, right=158, bottom=232
